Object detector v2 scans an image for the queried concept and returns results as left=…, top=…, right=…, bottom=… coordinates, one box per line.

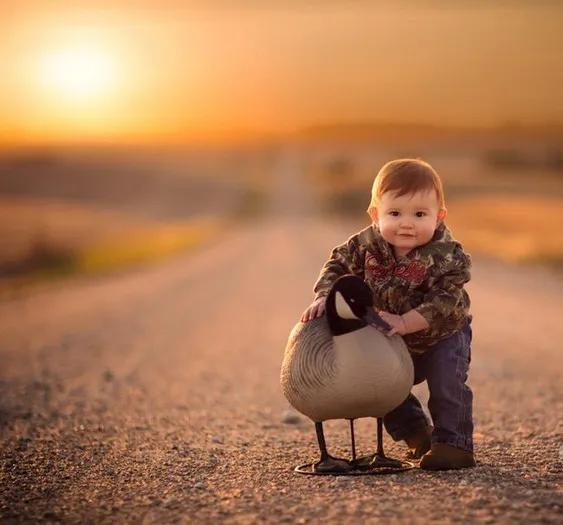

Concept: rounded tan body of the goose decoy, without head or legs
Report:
left=281, top=316, right=414, bottom=422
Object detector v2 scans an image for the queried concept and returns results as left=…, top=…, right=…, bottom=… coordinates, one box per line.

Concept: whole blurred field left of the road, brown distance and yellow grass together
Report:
left=0, top=148, right=276, bottom=289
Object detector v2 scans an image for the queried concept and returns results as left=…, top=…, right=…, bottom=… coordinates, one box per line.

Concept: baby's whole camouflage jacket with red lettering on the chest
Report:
left=314, top=223, right=471, bottom=353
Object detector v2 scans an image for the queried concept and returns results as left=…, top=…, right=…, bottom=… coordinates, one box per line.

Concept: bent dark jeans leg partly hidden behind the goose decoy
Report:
left=383, top=355, right=429, bottom=441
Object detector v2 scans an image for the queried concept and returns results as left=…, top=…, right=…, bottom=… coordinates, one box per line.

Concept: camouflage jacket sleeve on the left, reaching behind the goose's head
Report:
left=313, top=227, right=373, bottom=300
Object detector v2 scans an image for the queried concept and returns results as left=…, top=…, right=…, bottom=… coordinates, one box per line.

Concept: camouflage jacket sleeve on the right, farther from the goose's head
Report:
left=415, top=245, right=471, bottom=335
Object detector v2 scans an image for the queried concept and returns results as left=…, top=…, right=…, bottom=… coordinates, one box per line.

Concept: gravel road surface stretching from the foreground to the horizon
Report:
left=0, top=151, right=563, bottom=523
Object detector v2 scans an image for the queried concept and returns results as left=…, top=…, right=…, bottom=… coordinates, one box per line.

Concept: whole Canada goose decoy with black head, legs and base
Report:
left=280, top=275, right=414, bottom=473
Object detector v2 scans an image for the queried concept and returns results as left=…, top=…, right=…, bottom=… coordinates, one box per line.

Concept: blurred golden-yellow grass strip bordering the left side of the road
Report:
left=0, top=199, right=224, bottom=290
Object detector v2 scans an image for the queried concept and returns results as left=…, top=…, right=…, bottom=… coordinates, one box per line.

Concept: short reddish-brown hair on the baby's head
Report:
left=367, top=159, right=446, bottom=213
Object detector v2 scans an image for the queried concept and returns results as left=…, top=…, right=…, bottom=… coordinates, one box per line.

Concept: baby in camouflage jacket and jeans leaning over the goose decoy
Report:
left=301, top=159, right=475, bottom=470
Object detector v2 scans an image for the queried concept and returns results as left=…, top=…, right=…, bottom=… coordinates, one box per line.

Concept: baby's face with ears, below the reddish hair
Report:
left=371, top=190, right=447, bottom=255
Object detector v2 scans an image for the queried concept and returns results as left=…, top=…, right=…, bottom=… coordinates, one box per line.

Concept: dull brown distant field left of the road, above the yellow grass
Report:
left=0, top=147, right=270, bottom=220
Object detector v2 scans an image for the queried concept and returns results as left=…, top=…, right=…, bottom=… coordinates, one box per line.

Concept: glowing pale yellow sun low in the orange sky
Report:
left=40, top=47, right=115, bottom=101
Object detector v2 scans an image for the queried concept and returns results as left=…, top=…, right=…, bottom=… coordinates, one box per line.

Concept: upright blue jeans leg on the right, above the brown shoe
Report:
left=425, top=324, right=473, bottom=450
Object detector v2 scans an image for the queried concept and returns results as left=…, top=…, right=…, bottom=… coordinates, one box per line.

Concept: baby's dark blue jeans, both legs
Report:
left=383, top=322, right=473, bottom=451
